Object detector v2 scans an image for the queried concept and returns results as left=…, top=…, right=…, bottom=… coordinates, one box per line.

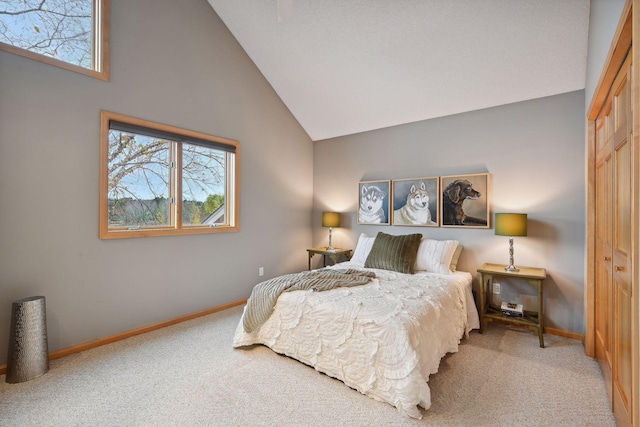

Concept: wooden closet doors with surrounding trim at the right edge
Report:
left=585, top=4, right=640, bottom=427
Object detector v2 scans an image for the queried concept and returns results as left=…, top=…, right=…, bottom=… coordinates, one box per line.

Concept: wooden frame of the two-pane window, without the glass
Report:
left=99, top=111, right=240, bottom=239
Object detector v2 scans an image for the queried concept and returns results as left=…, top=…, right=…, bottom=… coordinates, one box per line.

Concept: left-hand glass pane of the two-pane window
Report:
left=108, top=130, right=171, bottom=228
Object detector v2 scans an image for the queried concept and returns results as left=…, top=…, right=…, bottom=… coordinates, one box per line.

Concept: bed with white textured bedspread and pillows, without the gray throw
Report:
left=233, top=233, right=479, bottom=418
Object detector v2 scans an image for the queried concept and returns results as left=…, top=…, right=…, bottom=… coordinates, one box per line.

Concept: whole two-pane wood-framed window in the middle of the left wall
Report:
left=100, top=111, right=240, bottom=239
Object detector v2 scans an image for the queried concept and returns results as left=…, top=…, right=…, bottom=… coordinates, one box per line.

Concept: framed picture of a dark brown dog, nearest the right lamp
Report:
left=440, top=173, right=491, bottom=228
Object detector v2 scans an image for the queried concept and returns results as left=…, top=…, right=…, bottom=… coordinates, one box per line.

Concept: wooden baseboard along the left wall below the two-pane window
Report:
left=0, top=298, right=247, bottom=375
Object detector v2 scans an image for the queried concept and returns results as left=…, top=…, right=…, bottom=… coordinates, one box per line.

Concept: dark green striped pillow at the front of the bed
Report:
left=364, top=231, right=422, bottom=274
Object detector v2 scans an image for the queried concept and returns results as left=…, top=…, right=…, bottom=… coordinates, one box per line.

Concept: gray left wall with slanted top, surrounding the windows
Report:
left=0, top=0, right=313, bottom=364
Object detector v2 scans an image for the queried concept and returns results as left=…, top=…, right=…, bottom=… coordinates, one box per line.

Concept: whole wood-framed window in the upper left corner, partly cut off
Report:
left=0, top=0, right=109, bottom=80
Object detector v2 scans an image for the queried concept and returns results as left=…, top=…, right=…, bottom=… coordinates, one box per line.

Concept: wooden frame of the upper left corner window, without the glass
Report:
left=0, top=0, right=110, bottom=81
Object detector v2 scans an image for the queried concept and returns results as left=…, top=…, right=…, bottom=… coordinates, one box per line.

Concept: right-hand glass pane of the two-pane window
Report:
left=182, top=144, right=227, bottom=225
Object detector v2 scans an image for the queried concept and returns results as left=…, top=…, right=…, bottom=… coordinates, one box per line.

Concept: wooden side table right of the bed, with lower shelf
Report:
left=478, top=263, right=547, bottom=347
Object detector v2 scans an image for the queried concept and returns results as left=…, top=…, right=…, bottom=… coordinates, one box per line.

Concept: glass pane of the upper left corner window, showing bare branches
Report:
left=0, top=0, right=94, bottom=70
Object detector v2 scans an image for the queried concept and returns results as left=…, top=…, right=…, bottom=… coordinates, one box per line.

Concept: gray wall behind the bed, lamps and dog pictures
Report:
left=313, top=91, right=585, bottom=333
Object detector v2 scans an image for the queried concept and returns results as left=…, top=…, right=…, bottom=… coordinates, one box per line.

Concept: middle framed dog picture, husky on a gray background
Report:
left=391, top=176, right=440, bottom=227
